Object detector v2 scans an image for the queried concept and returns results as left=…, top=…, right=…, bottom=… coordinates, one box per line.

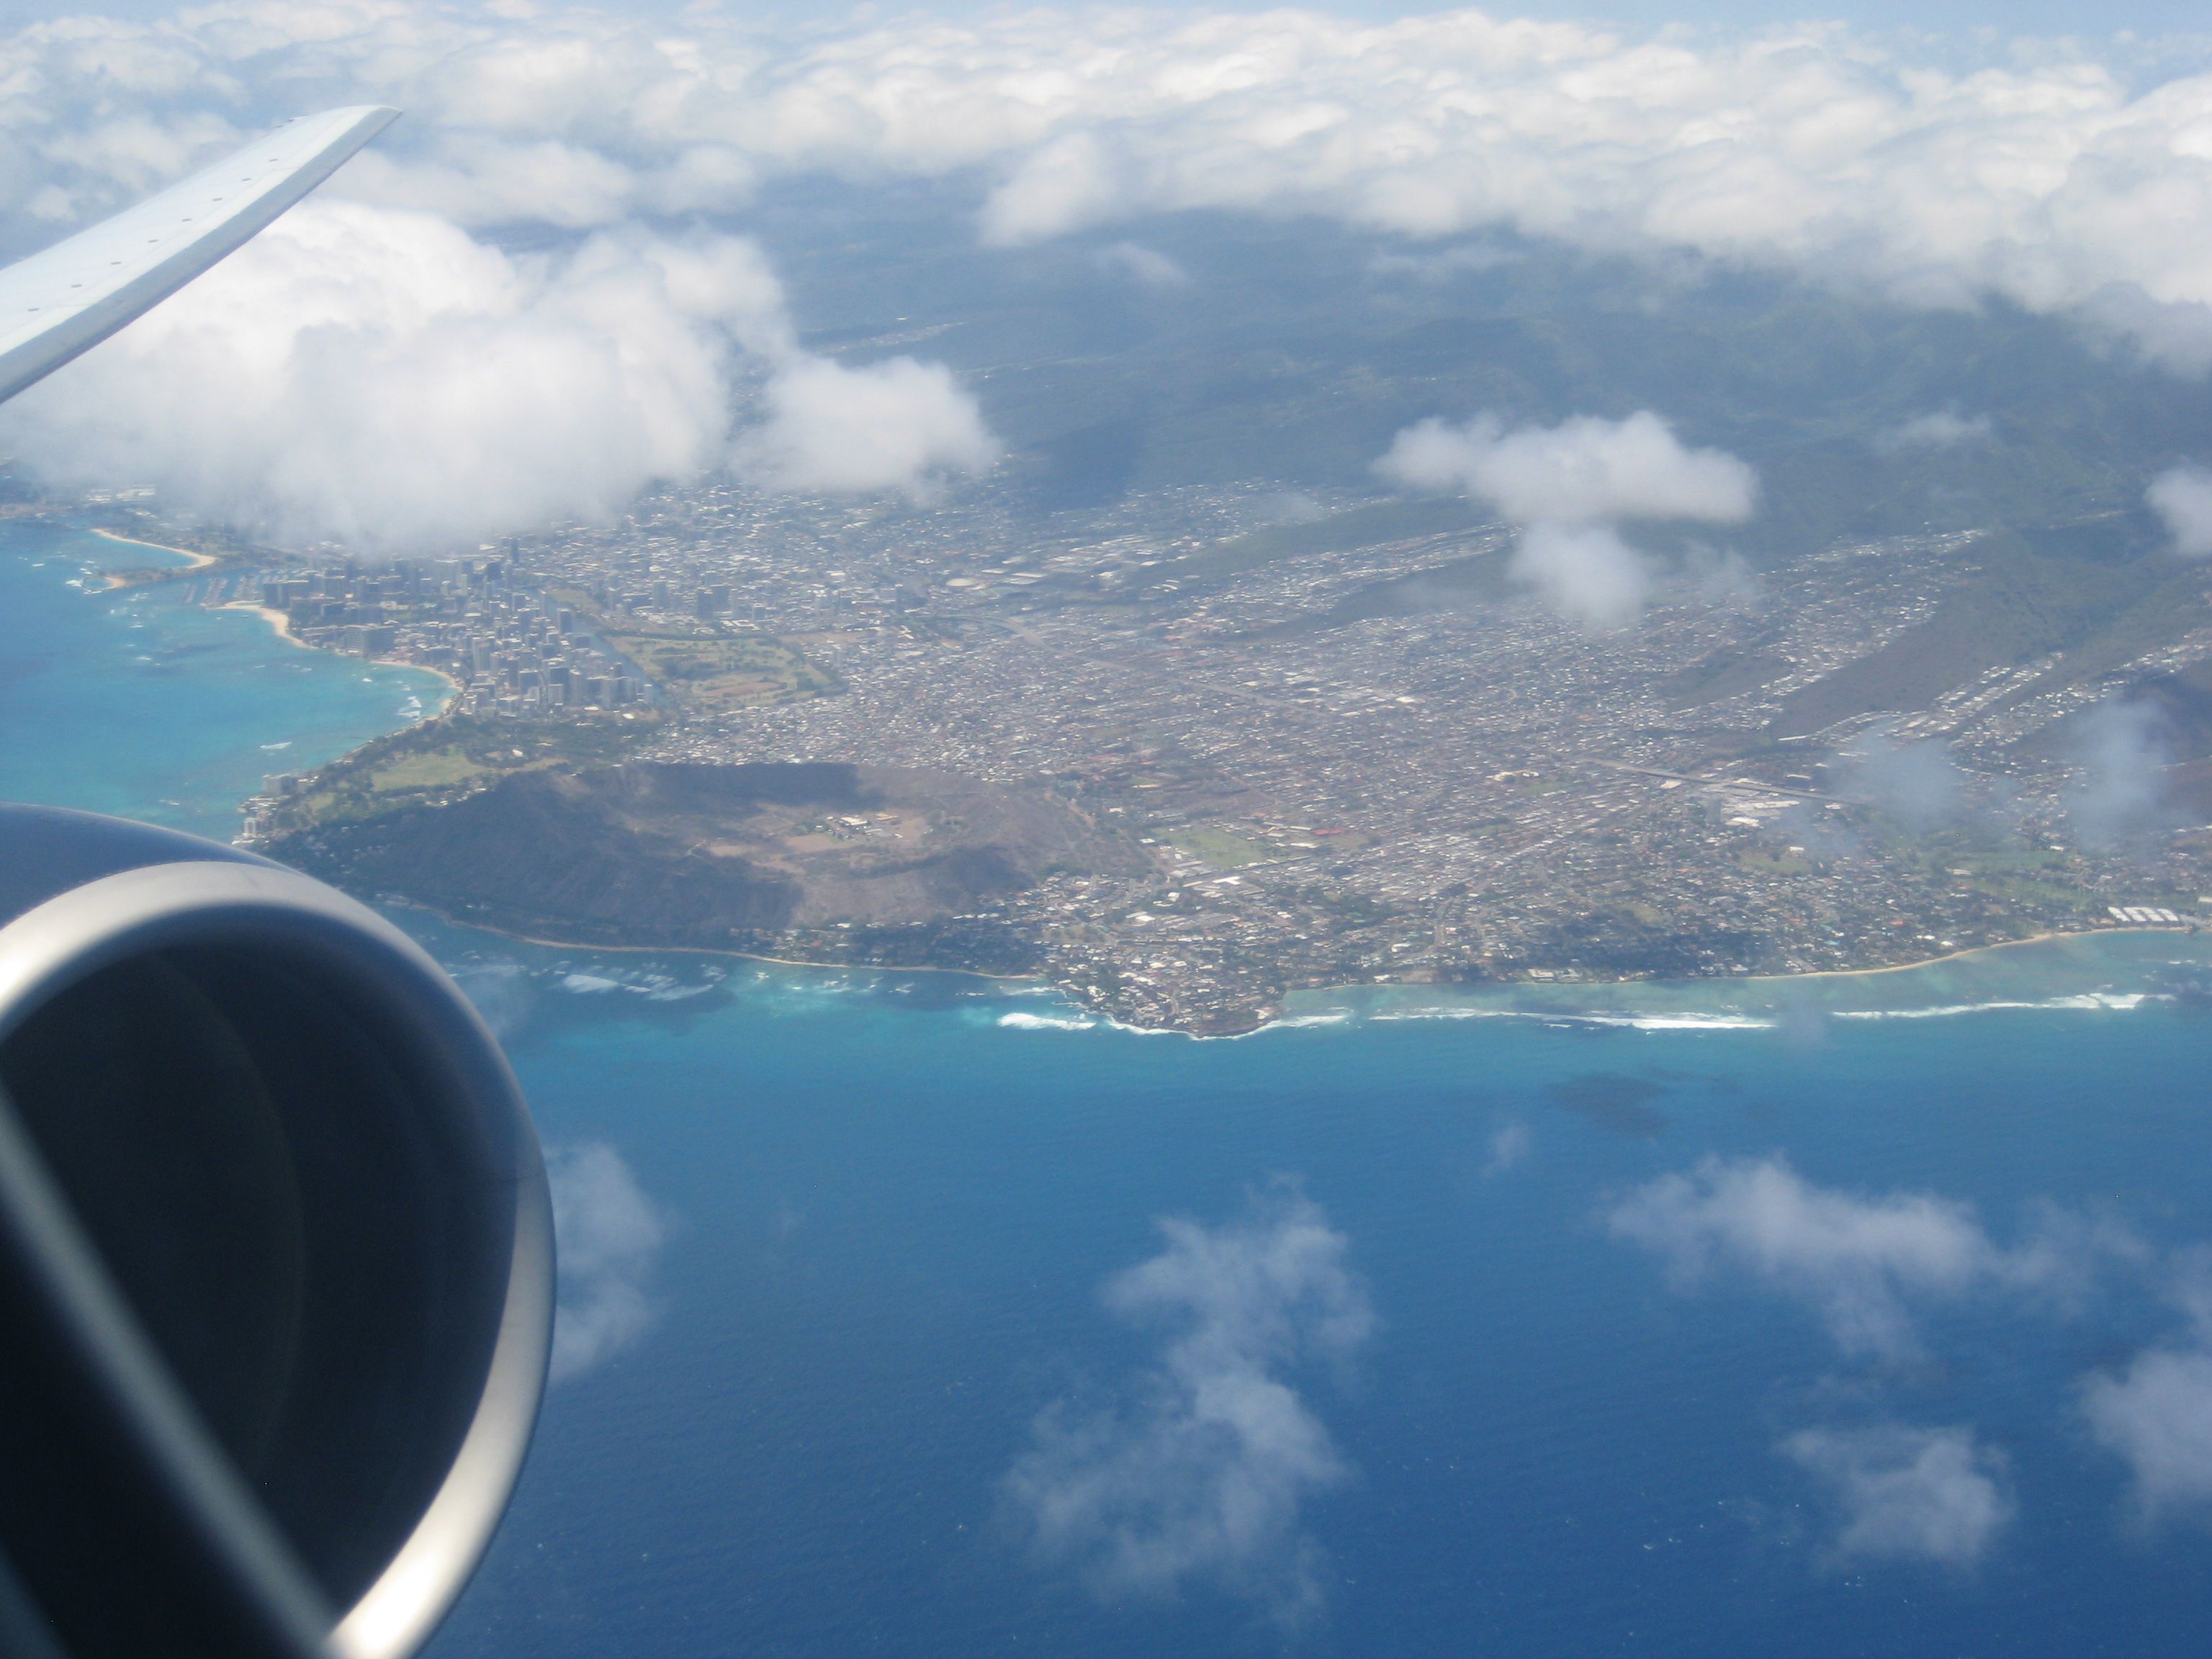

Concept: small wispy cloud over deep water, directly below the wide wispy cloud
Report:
left=1781, top=1424, right=2018, bottom=1568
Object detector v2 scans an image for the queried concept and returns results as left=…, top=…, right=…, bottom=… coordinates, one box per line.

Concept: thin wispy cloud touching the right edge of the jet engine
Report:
left=547, top=1141, right=668, bottom=1382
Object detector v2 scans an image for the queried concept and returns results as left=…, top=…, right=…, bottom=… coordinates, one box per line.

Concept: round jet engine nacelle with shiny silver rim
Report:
left=0, top=807, right=553, bottom=1659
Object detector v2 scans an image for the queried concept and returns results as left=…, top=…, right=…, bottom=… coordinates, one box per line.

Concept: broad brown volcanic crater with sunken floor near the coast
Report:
left=272, top=761, right=1148, bottom=966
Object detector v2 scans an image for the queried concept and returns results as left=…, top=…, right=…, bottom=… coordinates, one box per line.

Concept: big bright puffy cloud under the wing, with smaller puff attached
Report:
left=0, top=202, right=997, bottom=553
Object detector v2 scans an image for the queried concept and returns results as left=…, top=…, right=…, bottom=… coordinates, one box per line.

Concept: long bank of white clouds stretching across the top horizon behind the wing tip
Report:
left=13, top=0, right=2212, bottom=363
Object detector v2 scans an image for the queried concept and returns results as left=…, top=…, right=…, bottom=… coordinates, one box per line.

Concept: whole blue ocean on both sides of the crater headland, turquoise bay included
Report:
left=0, top=524, right=2212, bottom=1659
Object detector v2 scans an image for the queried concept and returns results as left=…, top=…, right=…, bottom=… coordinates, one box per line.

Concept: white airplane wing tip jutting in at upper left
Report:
left=0, top=104, right=398, bottom=403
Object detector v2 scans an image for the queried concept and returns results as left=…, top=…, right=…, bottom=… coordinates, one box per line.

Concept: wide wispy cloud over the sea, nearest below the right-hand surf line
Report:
left=1606, top=1157, right=2105, bottom=1360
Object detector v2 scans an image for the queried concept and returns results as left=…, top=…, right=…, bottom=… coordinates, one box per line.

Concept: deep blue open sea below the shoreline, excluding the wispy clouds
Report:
left=415, top=943, right=2212, bottom=1655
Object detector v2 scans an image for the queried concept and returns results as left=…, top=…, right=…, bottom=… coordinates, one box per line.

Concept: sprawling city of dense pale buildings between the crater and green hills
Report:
left=143, top=469, right=2212, bottom=1028
